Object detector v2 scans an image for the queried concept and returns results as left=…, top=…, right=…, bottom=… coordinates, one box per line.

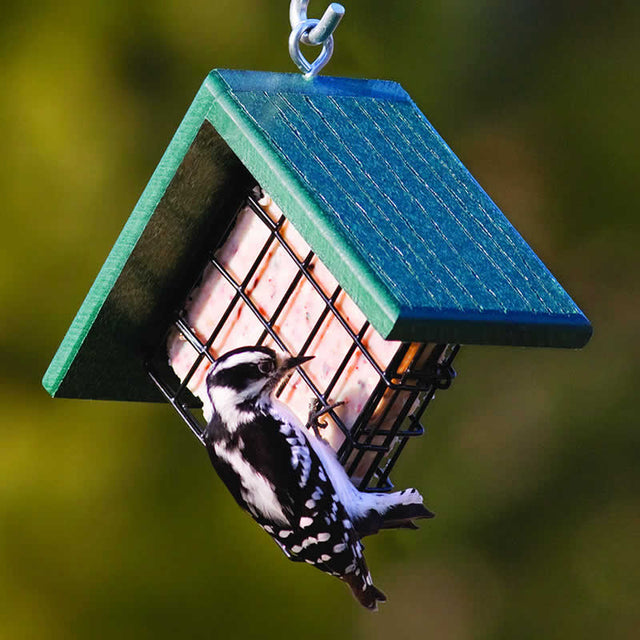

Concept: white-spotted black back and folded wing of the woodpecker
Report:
left=205, top=413, right=384, bottom=609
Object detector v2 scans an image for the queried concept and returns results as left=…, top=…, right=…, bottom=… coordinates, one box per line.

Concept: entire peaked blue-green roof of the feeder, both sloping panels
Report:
left=44, top=70, right=591, bottom=400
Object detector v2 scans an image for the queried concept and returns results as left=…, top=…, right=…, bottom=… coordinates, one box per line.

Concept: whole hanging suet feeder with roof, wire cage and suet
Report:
left=44, top=70, right=591, bottom=490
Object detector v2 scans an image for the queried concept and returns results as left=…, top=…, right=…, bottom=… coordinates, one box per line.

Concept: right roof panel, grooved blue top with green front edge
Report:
left=206, top=71, right=591, bottom=347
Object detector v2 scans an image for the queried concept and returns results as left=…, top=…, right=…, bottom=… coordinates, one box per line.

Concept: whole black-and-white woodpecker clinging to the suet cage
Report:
left=204, top=347, right=433, bottom=610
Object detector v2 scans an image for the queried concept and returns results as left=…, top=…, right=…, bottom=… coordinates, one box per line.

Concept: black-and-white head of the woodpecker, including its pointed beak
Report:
left=207, top=347, right=313, bottom=415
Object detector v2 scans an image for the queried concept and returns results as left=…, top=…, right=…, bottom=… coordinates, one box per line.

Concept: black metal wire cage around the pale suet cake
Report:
left=147, top=188, right=459, bottom=491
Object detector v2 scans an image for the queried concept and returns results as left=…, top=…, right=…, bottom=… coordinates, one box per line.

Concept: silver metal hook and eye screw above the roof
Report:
left=289, top=0, right=345, bottom=79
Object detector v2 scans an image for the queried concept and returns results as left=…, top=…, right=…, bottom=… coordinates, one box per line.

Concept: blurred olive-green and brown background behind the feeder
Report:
left=0, top=0, right=640, bottom=640
